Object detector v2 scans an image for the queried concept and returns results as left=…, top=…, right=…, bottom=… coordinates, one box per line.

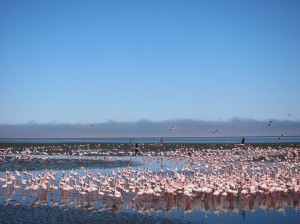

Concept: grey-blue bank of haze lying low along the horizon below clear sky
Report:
left=0, top=119, right=300, bottom=138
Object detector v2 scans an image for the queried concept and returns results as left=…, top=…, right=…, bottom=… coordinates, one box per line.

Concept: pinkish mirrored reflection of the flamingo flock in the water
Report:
left=0, top=183, right=300, bottom=216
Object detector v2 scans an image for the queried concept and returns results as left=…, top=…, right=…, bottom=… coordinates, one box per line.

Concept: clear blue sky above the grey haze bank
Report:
left=0, top=0, right=300, bottom=137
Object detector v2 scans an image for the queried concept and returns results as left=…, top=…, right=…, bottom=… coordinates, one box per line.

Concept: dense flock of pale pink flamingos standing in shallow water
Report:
left=0, top=146, right=300, bottom=214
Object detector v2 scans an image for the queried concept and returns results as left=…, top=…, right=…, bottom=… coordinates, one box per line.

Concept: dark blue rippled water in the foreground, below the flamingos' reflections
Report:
left=0, top=205, right=299, bottom=224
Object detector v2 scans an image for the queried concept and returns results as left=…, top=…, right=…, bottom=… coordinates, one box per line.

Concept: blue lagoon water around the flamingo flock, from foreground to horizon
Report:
left=0, top=137, right=300, bottom=224
